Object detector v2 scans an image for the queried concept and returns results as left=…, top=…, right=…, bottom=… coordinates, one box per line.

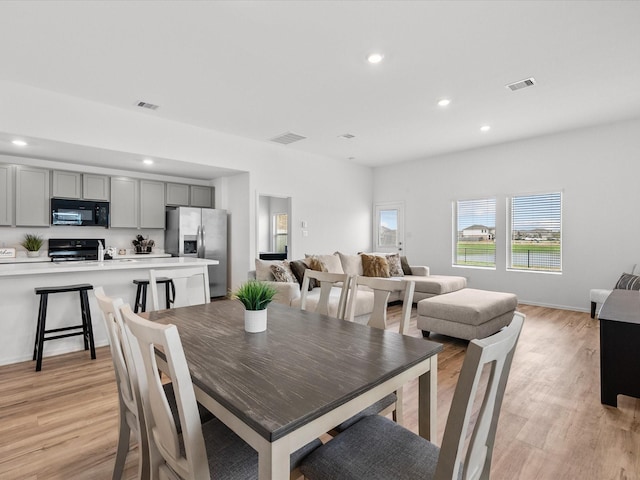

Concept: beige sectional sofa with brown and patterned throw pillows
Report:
left=249, top=252, right=467, bottom=323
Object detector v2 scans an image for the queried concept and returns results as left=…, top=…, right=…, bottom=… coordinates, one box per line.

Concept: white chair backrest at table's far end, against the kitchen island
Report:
left=149, top=265, right=211, bottom=310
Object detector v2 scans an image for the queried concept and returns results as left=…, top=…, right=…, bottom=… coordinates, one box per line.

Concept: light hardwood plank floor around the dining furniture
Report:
left=0, top=305, right=640, bottom=480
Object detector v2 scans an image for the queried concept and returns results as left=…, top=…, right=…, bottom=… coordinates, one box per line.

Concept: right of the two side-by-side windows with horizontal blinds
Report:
left=507, top=192, right=562, bottom=272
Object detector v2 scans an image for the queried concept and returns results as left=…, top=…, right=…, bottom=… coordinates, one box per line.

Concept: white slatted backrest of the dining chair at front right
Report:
left=435, top=312, right=525, bottom=480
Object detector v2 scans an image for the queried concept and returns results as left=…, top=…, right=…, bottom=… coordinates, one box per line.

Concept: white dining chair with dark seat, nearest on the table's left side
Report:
left=120, top=305, right=321, bottom=480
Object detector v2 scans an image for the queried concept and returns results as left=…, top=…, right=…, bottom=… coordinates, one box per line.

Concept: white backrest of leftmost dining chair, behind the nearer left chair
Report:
left=94, top=287, right=149, bottom=479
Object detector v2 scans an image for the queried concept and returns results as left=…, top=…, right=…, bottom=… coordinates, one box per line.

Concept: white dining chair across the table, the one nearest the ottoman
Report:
left=332, top=275, right=415, bottom=433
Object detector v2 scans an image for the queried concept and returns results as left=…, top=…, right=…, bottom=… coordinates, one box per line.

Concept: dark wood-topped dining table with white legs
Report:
left=141, top=299, right=442, bottom=480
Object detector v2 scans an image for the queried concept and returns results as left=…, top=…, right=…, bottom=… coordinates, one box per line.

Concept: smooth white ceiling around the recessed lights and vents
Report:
left=0, top=1, right=640, bottom=178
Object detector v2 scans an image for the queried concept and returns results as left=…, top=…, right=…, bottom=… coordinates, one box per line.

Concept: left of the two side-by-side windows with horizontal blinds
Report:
left=453, top=198, right=496, bottom=268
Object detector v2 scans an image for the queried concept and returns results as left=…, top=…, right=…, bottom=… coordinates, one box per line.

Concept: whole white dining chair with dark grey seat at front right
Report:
left=300, top=312, right=525, bottom=480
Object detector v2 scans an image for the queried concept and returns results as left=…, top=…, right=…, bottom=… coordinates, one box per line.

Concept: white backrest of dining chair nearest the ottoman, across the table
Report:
left=347, top=275, right=415, bottom=334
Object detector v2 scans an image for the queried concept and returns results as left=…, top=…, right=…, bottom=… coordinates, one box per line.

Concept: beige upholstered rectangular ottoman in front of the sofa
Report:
left=417, top=288, right=518, bottom=340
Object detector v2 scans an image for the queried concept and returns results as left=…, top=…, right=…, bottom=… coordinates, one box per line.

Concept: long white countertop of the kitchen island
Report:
left=0, top=254, right=219, bottom=277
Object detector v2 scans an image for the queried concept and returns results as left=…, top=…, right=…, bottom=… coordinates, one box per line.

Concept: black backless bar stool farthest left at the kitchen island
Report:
left=33, top=283, right=96, bottom=372
